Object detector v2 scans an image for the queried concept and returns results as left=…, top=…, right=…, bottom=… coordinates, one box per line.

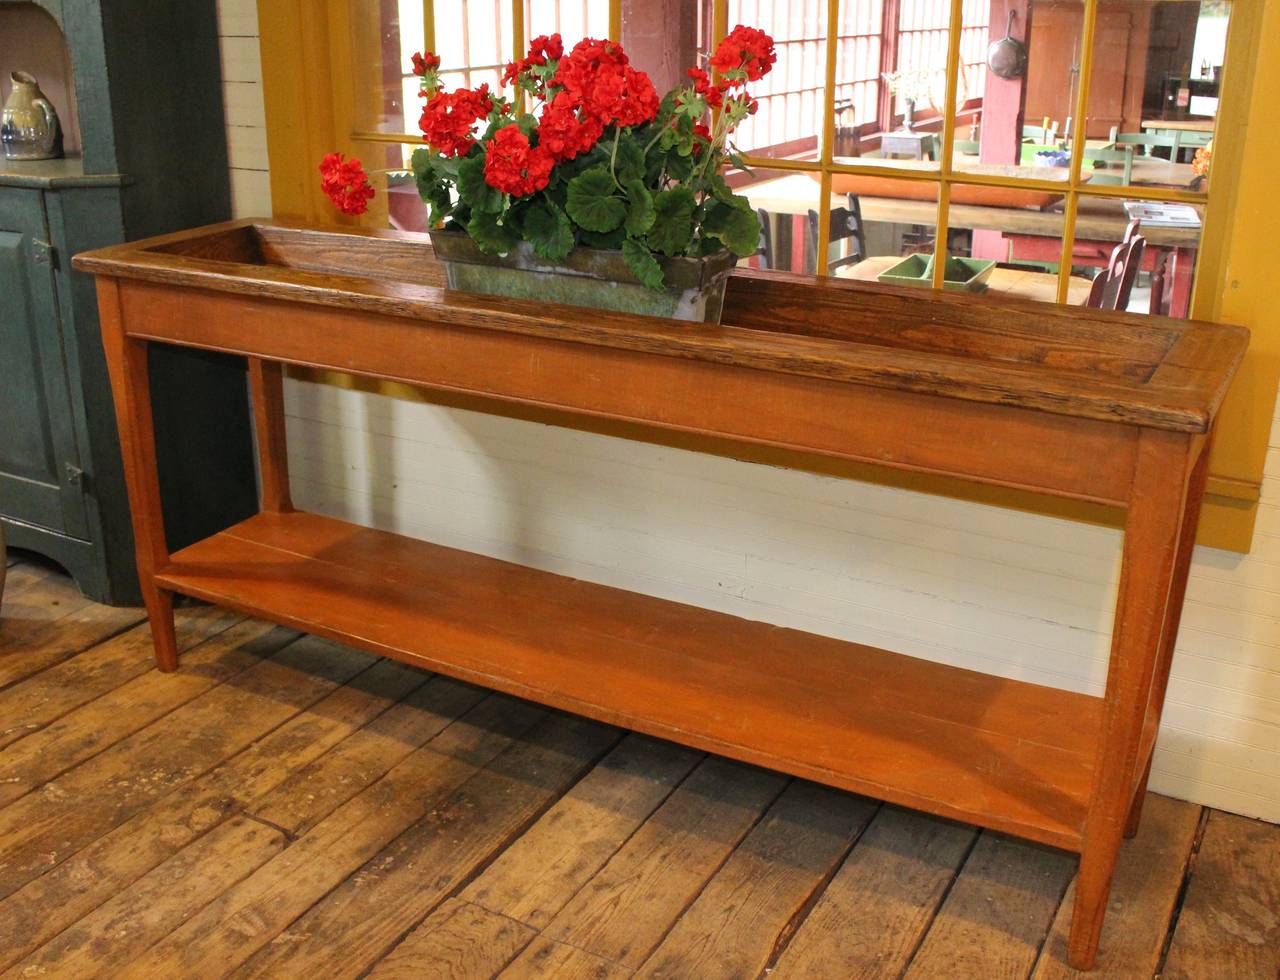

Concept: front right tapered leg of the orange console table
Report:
left=1068, top=430, right=1192, bottom=970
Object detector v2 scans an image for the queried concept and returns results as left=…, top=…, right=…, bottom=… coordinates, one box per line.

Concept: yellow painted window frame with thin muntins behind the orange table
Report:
left=259, top=0, right=1280, bottom=551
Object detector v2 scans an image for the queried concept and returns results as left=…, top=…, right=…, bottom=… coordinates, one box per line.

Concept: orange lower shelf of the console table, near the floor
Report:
left=156, top=512, right=1102, bottom=851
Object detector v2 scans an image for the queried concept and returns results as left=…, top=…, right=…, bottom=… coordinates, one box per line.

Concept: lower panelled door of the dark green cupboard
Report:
left=0, top=187, right=87, bottom=537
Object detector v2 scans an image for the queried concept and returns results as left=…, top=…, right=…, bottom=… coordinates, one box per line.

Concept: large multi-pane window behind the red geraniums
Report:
left=348, top=0, right=1230, bottom=316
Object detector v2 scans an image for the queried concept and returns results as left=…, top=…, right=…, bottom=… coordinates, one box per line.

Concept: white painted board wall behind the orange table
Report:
left=220, top=0, right=1280, bottom=823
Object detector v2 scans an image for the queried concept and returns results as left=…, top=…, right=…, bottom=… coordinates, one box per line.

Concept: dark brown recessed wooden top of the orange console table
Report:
left=73, top=220, right=1248, bottom=432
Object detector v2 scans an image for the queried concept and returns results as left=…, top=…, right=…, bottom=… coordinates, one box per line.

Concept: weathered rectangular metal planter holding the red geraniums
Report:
left=431, top=232, right=737, bottom=324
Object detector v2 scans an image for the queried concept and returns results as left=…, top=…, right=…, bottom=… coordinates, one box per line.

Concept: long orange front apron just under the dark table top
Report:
left=120, top=280, right=1140, bottom=505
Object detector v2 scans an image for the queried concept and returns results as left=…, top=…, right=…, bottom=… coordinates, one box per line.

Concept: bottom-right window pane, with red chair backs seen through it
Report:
left=1071, top=191, right=1203, bottom=319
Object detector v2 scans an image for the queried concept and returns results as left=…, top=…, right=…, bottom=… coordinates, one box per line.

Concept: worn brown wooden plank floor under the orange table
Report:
left=0, top=557, right=1280, bottom=980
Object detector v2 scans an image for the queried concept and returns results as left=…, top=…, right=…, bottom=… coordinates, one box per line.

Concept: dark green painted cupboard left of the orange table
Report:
left=0, top=0, right=256, bottom=604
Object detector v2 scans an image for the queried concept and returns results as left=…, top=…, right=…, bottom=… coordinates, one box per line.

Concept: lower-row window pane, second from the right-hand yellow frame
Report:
left=947, top=184, right=1089, bottom=304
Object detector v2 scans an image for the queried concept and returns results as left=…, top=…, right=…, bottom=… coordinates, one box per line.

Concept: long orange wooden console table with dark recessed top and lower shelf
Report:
left=76, top=221, right=1247, bottom=967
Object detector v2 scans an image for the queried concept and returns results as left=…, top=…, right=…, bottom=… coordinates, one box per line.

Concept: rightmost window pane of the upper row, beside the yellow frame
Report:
left=1087, top=0, right=1230, bottom=191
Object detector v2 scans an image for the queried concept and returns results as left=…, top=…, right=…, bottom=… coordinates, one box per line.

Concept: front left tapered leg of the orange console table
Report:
left=97, top=278, right=178, bottom=670
